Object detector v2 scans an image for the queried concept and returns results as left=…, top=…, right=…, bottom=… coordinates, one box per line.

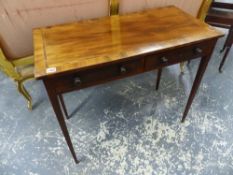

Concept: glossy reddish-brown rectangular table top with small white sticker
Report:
left=33, top=6, right=222, bottom=78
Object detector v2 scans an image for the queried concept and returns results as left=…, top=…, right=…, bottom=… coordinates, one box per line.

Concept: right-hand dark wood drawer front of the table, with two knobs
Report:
left=145, top=42, right=211, bottom=70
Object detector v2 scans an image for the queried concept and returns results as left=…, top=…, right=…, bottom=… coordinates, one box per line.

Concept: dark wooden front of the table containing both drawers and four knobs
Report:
left=47, top=39, right=216, bottom=93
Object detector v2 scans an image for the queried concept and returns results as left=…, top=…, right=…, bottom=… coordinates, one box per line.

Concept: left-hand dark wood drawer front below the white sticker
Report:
left=51, top=59, right=144, bottom=93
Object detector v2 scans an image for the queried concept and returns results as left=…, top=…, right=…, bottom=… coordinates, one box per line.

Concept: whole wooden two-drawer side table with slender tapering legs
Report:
left=34, top=7, right=223, bottom=163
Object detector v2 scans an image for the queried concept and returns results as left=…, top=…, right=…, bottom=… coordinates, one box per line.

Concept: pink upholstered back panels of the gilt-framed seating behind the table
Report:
left=0, top=0, right=202, bottom=58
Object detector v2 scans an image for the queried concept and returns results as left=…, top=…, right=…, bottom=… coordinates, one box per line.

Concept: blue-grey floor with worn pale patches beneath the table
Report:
left=0, top=29, right=233, bottom=175
